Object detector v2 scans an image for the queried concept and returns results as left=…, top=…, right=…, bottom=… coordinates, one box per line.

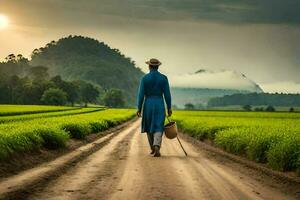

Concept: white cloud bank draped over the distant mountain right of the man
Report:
left=169, top=70, right=258, bottom=92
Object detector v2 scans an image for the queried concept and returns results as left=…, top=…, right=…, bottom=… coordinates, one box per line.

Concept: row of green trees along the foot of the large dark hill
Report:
left=0, top=54, right=125, bottom=107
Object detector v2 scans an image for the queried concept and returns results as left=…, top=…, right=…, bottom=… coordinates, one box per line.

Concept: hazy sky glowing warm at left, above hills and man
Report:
left=0, top=0, right=300, bottom=93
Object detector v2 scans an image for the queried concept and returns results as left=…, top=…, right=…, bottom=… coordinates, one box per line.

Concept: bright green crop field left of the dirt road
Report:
left=0, top=106, right=135, bottom=160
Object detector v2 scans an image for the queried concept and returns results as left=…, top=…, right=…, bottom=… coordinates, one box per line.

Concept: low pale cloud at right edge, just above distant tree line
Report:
left=261, top=81, right=300, bottom=94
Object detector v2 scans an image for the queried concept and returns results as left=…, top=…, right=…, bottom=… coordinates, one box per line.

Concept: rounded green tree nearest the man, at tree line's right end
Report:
left=103, top=88, right=125, bottom=107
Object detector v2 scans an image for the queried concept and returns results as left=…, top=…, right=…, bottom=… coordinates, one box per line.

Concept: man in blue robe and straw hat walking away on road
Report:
left=137, top=58, right=172, bottom=157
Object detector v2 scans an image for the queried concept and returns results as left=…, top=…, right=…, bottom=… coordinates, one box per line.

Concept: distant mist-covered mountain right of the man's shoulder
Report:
left=169, top=69, right=263, bottom=108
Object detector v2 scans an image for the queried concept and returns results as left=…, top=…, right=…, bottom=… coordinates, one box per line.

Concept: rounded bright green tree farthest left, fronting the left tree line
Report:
left=41, top=88, right=67, bottom=105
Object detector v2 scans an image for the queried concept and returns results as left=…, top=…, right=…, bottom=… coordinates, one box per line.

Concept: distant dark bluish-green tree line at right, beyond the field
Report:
left=208, top=93, right=300, bottom=107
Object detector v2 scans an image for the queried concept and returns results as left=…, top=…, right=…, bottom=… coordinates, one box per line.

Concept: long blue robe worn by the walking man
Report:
left=138, top=69, right=171, bottom=133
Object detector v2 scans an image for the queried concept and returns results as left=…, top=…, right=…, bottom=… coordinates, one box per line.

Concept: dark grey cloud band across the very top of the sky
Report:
left=4, top=0, right=300, bottom=25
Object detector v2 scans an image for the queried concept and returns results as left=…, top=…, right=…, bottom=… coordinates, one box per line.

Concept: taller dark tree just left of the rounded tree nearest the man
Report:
left=79, top=81, right=99, bottom=107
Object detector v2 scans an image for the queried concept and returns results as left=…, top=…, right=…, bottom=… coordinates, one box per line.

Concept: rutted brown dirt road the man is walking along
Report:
left=0, top=121, right=295, bottom=200
